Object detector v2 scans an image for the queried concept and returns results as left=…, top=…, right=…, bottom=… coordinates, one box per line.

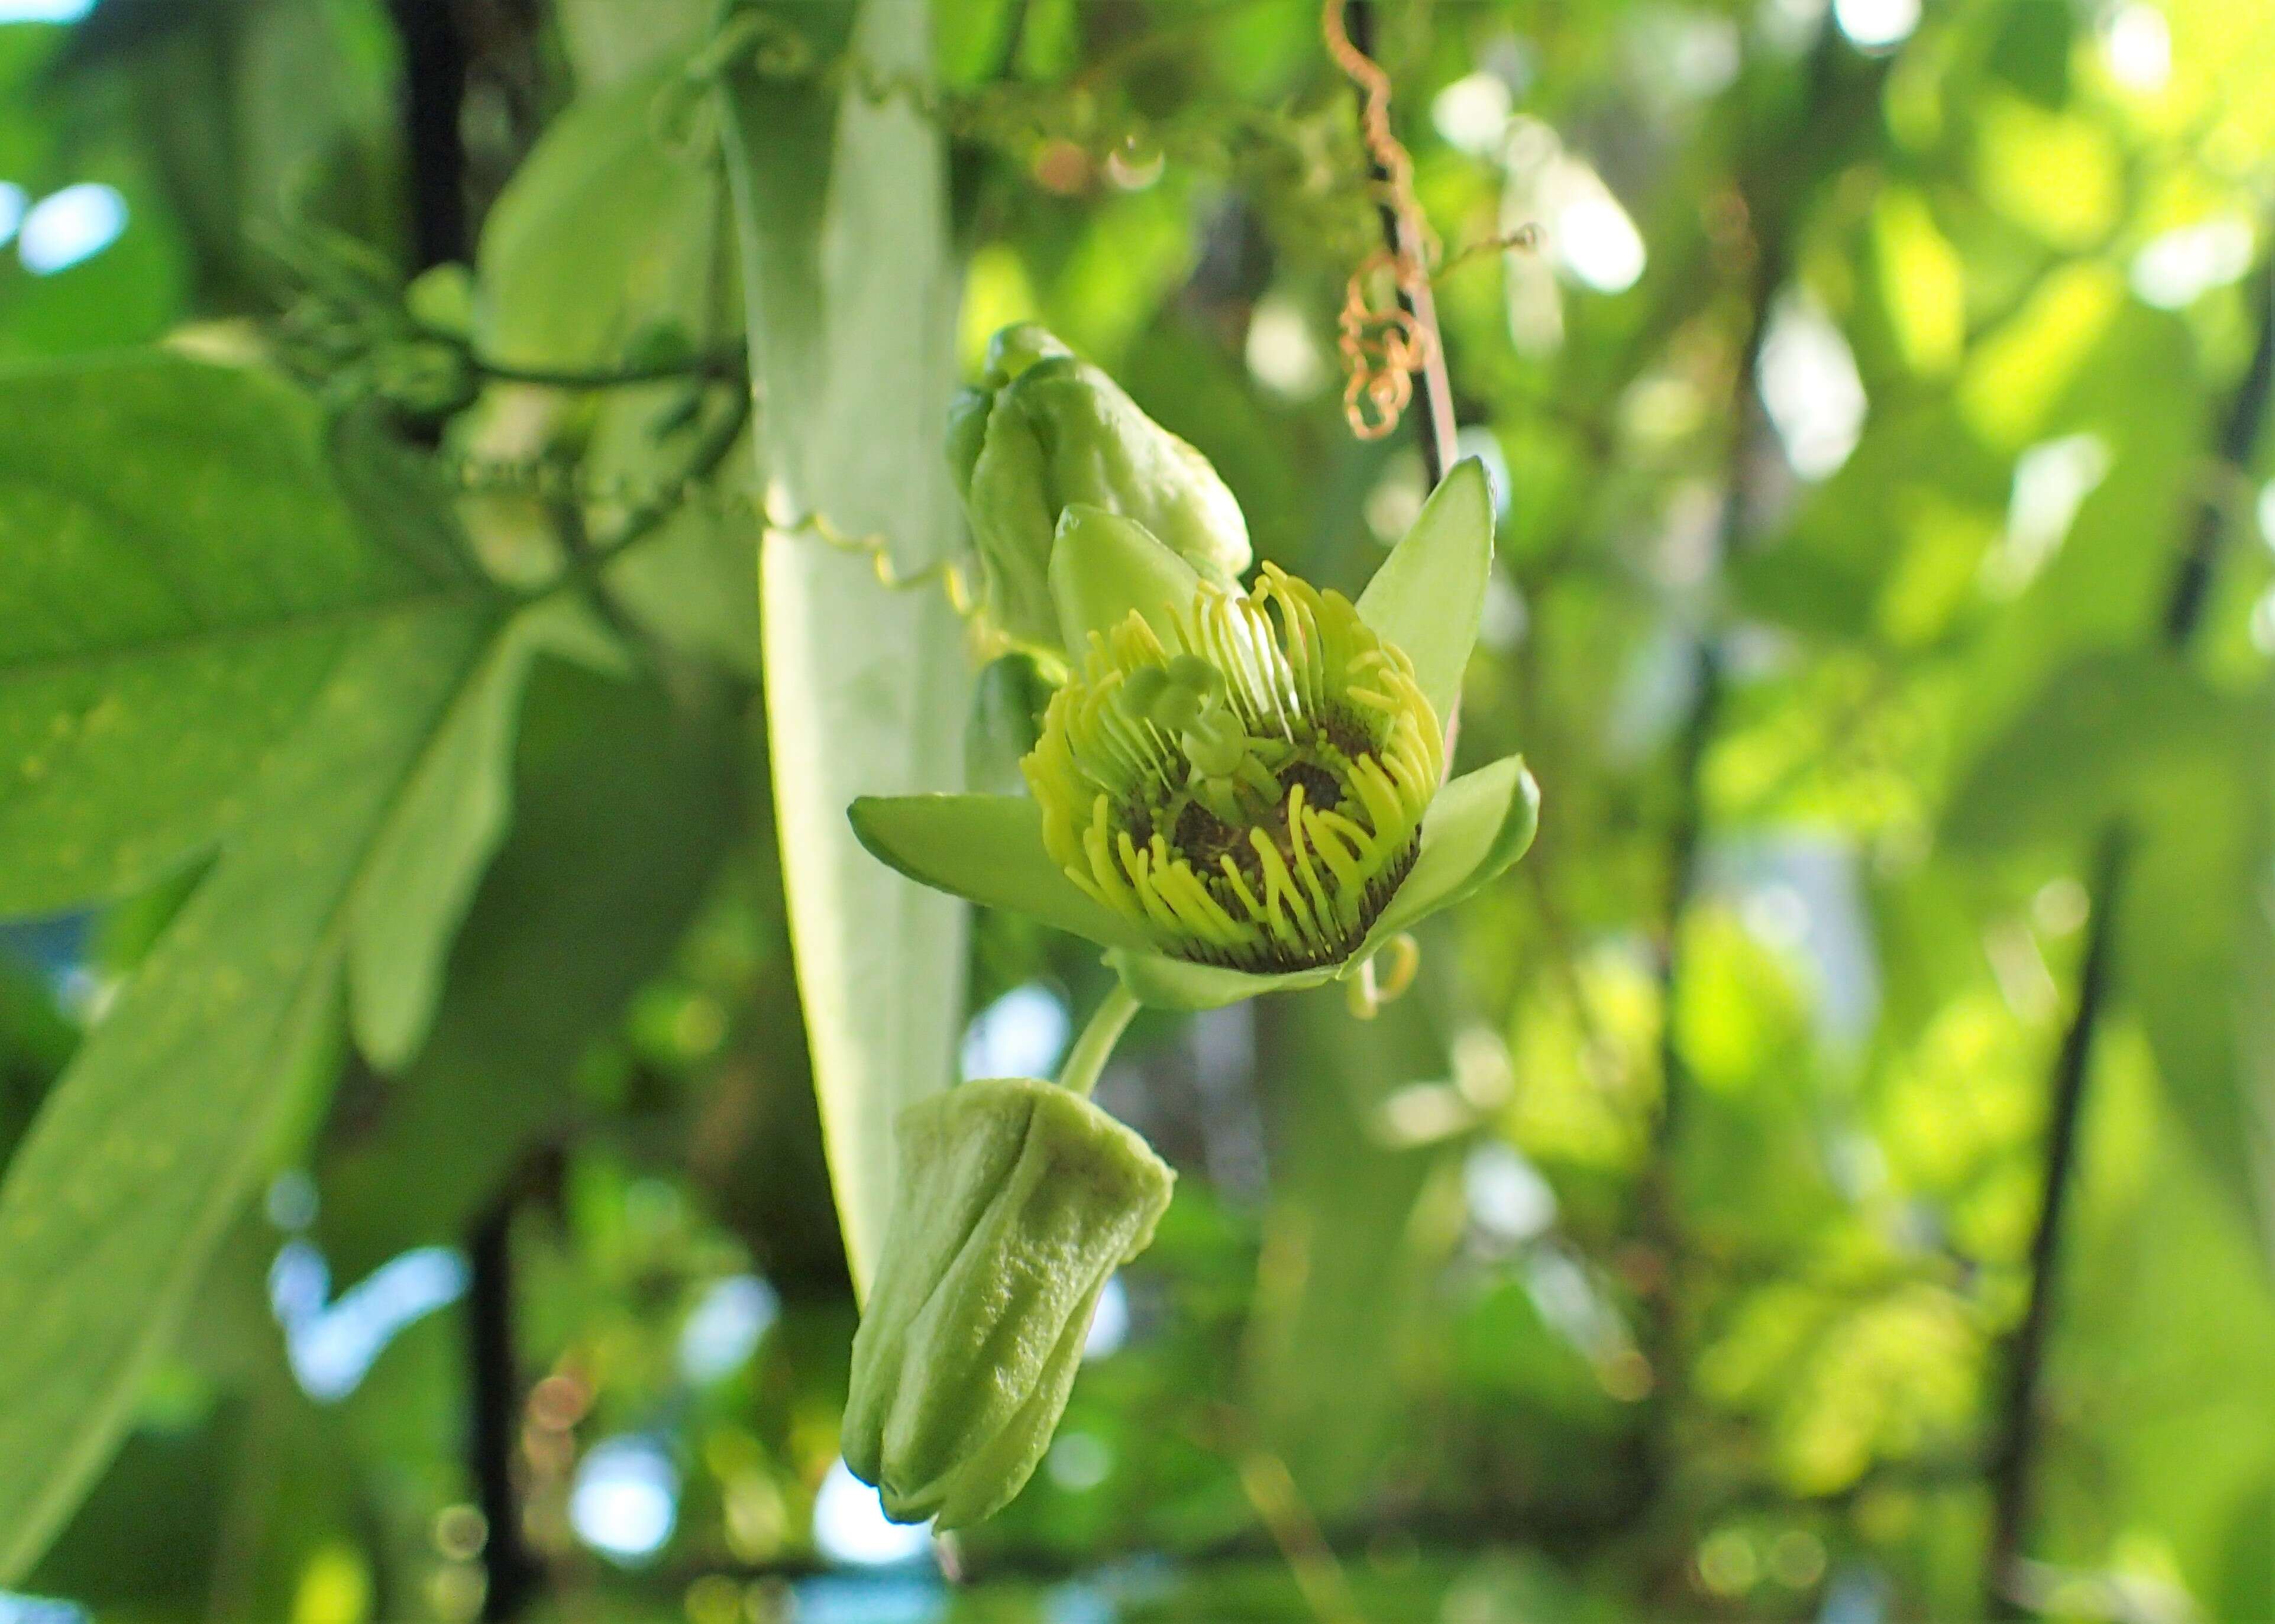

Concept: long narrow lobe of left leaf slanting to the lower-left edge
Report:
left=0, top=605, right=492, bottom=1583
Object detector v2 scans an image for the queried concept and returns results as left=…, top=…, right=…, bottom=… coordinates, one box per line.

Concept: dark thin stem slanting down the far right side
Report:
left=1984, top=237, right=2275, bottom=1617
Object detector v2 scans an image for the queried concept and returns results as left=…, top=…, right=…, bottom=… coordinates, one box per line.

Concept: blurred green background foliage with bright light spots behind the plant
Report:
left=0, top=0, right=2275, bottom=1624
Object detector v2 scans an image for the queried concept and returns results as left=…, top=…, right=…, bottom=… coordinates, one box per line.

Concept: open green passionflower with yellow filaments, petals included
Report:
left=851, top=460, right=1540, bottom=1010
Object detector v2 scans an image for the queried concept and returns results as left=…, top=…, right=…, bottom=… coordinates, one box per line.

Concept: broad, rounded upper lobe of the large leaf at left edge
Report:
left=0, top=355, right=482, bottom=914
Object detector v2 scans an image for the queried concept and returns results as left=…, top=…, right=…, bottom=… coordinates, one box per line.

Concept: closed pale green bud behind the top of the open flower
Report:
left=949, top=323, right=1249, bottom=653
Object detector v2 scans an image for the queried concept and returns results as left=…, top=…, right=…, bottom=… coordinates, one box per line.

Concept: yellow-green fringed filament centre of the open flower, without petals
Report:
left=1024, top=564, right=1445, bottom=971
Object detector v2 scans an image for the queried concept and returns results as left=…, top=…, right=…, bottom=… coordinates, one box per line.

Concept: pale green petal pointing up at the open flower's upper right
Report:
left=1358, top=457, right=1492, bottom=721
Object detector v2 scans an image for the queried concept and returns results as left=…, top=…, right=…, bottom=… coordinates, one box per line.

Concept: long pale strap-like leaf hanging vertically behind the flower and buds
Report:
left=719, top=0, right=969, bottom=1285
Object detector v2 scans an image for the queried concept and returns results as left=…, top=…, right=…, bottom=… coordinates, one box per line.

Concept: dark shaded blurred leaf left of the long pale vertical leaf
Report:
left=318, top=659, right=742, bottom=1280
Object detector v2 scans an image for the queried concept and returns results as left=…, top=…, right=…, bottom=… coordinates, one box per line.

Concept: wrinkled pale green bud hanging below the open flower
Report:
left=844, top=1078, right=1174, bottom=1528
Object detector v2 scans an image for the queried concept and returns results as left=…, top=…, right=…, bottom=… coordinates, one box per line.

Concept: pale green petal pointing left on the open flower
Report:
left=846, top=796, right=1146, bottom=946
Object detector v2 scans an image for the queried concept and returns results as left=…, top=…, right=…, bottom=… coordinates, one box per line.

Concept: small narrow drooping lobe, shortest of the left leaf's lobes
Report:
left=348, top=598, right=614, bottom=1071
